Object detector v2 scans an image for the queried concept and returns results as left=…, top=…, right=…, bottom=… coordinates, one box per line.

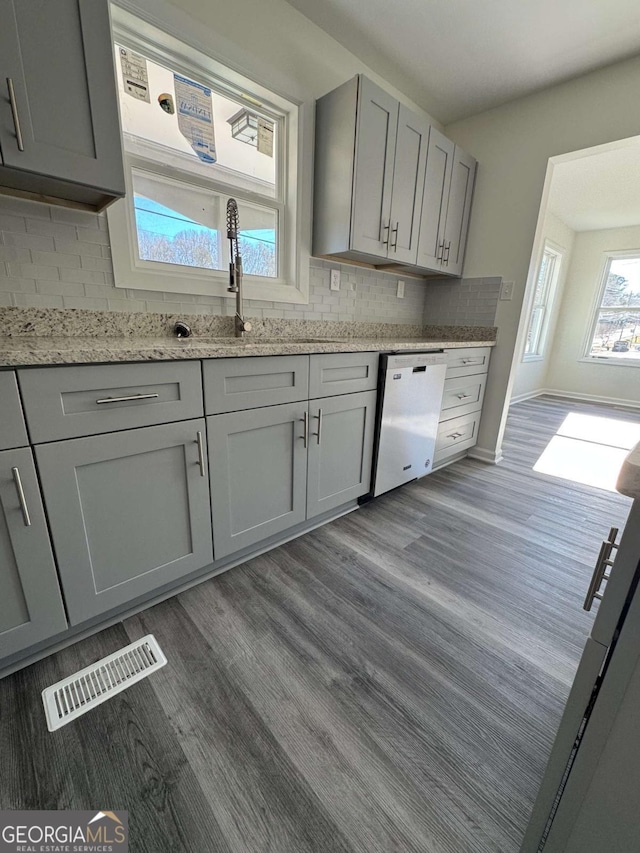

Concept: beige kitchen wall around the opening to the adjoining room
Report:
left=445, top=58, right=640, bottom=454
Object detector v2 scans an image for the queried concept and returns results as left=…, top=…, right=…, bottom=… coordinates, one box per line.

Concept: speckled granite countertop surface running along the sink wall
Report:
left=0, top=335, right=495, bottom=368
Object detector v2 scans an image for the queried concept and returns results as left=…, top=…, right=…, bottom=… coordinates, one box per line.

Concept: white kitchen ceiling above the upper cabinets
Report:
left=288, top=0, right=640, bottom=124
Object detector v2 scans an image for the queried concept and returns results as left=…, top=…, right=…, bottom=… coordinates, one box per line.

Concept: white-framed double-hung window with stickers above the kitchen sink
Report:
left=108, top=12, right=307, bottom=302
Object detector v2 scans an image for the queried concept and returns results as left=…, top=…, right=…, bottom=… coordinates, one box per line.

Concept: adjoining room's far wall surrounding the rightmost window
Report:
left=544, top=226, right=640, bottom=405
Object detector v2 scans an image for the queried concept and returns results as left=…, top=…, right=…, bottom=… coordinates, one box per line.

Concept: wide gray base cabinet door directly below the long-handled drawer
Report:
left=36, top=419, right=213, bottom=625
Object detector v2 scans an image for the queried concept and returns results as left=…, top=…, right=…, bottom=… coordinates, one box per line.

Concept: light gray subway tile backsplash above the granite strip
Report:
left=0, top=196, right=500, bottom=326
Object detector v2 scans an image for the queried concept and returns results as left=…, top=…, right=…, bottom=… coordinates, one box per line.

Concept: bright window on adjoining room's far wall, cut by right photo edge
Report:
left=586, top=250, right=640, bottom=364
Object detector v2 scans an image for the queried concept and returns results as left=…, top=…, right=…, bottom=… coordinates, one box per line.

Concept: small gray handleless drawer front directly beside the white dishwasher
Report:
left=309, top=352, right=379, bottom=400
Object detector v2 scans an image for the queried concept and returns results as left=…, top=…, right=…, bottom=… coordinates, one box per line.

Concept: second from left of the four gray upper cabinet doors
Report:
left=389, top=104, right=429, bottom=264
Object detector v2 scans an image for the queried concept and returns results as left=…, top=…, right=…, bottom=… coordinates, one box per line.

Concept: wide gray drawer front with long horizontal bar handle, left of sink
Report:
left=18, top=361, right=203, bottom=444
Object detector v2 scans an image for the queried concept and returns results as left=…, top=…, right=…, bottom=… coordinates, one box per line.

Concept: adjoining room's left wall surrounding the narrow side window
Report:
left=511, top=211, right=576, bottom=397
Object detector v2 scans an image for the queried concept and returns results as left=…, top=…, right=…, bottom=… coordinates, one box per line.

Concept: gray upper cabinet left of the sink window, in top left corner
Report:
left=0, top=0, right=125, bottom=209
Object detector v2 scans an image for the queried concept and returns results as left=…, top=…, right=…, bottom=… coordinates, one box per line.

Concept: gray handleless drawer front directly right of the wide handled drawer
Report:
left=204, top=355, right=309, bottom=415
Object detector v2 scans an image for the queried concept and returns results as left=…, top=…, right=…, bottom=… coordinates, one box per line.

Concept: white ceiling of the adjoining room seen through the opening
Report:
left=547, top=139, right=640, bottom=231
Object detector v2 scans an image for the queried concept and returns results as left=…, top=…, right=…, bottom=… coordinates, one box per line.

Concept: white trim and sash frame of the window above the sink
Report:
left=107, top=5, right=309, bottom=304
